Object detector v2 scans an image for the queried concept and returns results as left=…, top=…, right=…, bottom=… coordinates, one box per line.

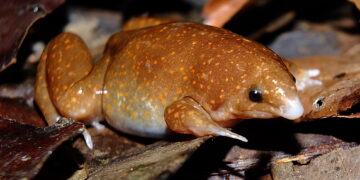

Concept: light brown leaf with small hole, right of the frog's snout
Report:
left=292, top=56, right=360, bottom=120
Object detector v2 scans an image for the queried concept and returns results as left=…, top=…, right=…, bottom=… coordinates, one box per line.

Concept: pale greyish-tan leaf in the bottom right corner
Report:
left=271, top=146, right=360, bottom=180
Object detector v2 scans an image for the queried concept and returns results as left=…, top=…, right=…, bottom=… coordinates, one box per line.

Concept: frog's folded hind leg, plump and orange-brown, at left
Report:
left=35, top=33, right=109, bottom=124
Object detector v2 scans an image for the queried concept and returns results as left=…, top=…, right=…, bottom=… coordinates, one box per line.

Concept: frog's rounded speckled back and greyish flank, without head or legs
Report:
left=103, top=23, right=282, bottom=137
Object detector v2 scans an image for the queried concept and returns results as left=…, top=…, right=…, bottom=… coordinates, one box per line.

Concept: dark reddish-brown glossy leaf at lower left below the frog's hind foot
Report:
left=0, top=118, right=85, bottom=179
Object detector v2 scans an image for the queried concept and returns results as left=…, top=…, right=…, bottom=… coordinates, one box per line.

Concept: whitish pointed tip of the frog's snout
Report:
left=279, top=97, right=304, bottom=120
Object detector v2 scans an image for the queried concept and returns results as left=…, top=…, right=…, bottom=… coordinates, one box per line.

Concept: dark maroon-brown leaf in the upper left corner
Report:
left=0, top=0, right=65, bottom=71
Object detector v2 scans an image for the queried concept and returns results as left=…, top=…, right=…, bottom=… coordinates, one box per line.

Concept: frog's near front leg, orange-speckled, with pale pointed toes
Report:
left=165, top=97, right=247, bottom=142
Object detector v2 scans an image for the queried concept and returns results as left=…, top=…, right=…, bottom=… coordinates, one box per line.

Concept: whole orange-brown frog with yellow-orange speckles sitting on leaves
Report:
left=35, top=22, right=303, bottom=141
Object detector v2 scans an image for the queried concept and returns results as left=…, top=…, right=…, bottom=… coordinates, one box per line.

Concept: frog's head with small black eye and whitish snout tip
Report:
left=234, top=52, right=304, bottom=119
